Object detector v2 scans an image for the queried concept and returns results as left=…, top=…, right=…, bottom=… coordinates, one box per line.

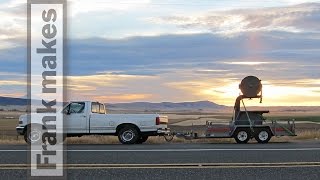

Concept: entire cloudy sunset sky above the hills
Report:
left=0, top=0, right=320, bottom=106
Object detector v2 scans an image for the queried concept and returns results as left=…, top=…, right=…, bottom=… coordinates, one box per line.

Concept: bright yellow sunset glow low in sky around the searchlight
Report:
left=202, top=82, right=320, bottom=106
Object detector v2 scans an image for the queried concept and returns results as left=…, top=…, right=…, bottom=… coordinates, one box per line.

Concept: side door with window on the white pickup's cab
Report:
left=63, top=102, right=88, bottom=134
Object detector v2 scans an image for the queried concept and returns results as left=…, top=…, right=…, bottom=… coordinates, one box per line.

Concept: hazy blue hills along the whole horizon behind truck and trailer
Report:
left=0, top=96, right=320, bottom=114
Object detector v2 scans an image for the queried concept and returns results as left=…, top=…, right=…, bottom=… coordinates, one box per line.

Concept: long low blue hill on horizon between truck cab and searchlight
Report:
left=106, top=101, right=225, bottom=110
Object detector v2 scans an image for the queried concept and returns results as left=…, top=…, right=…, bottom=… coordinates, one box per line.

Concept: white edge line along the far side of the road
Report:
left=0, top=148, right=320, bottom=152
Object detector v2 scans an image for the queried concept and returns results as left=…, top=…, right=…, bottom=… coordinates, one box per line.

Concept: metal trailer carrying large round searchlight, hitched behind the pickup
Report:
left=166, top=76, right=296, bottom=143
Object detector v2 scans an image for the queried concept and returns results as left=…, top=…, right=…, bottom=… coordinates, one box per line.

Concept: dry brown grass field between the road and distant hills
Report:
left=0, top=111, right=320, bottom=144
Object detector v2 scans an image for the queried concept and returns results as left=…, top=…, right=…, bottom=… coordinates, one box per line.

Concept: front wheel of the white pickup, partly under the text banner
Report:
left=24, top=125, right=44, bottom=144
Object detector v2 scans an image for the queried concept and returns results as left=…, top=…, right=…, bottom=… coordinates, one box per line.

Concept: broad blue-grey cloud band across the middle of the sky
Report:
left=0, top=32, right=320, bottom=79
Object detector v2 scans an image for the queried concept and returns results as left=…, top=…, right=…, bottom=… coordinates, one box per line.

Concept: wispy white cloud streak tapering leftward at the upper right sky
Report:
left=147, top=3, right=320, bottom=36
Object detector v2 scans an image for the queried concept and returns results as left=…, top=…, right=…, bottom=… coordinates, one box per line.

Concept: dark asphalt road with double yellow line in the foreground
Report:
left=0, top=141, right=320, bottom=180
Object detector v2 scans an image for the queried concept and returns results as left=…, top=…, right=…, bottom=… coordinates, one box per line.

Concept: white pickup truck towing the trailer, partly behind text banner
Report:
left=16, top=101, right=169, bottom=144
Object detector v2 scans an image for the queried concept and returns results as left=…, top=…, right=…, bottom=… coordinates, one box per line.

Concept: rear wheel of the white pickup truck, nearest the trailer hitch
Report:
left=118, top=126, right=140, bottom=144
